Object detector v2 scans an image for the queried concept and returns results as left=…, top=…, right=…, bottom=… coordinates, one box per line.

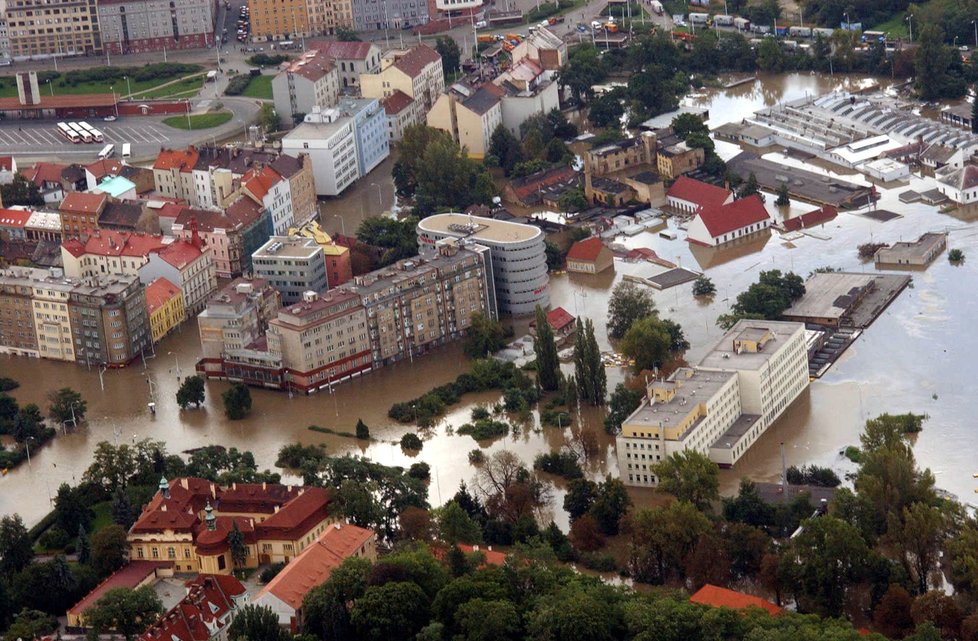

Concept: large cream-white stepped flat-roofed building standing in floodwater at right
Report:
left=616, top=320, right=809, bottom=487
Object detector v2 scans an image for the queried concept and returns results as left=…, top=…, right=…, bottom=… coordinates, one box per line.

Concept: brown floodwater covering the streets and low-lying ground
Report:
left=0, top=74, right=978, bottom=527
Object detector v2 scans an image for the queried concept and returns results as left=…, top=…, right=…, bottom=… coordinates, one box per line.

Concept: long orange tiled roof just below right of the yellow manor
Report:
left=253, top=523, right=376, bottom=610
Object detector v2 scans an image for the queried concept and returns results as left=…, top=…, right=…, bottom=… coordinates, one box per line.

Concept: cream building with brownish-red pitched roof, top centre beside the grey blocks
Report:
left=360, top=44, right=445, bottom=112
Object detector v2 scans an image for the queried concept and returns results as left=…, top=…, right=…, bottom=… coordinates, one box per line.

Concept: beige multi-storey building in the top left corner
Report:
left=5, top=0, right=102, bottom=60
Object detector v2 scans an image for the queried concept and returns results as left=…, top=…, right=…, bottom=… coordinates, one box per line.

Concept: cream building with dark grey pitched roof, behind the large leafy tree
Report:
left=428, top=87, right=503, bottom=159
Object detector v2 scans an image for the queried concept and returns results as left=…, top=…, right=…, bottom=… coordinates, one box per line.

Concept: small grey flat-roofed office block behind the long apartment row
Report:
left=251, top=236, right=328, bottom=306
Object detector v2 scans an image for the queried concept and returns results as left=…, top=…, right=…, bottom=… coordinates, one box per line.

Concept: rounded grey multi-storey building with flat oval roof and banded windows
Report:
left=418, top=213, right=550, bottom=316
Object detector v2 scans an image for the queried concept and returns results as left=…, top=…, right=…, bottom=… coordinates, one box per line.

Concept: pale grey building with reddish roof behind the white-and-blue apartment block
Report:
left=272, top=50, right=340, bottom=126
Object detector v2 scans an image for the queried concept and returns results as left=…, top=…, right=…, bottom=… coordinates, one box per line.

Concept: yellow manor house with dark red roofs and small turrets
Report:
left=128, top=478, right=336, bottom=574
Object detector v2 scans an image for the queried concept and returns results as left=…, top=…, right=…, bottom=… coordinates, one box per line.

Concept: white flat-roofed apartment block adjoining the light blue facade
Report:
left=282, top=109, right=360, bottom=196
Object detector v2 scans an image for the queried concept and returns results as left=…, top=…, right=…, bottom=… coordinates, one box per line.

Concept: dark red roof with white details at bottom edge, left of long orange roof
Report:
left=138, top=574, right=245, bottom=641
